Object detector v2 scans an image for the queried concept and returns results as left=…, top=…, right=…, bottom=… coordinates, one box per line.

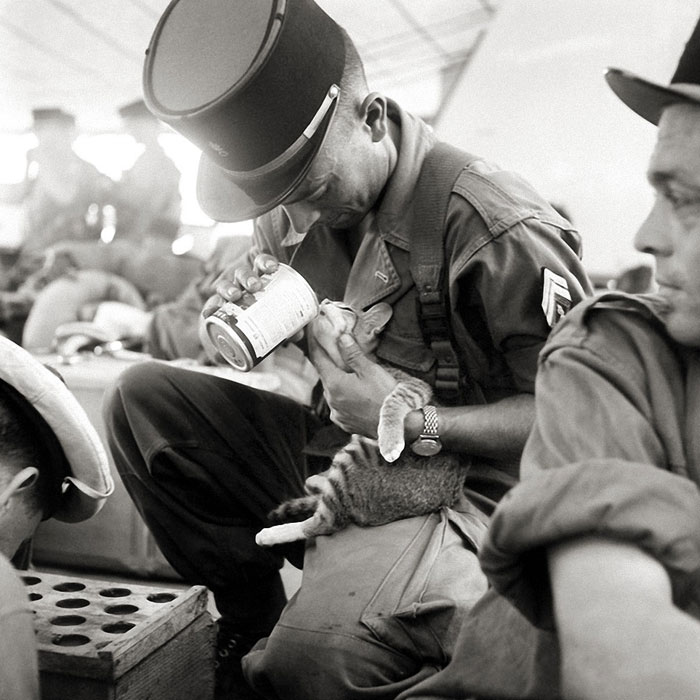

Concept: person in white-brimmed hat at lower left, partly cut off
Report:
left=0, top=336, right=114, bottom=700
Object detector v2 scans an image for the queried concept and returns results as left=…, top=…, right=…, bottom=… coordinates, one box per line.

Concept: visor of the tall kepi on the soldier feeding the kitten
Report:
left=197, top=101, right=337, bottom=222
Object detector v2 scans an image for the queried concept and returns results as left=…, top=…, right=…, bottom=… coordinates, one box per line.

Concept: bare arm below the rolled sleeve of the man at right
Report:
left=549, top=537, right=700, bottom=700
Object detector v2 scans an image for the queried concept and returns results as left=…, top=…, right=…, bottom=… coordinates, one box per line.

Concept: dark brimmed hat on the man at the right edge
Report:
left=605, top=15, right=700, bottom=124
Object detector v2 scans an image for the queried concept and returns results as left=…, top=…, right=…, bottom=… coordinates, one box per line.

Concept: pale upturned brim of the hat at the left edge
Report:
left=0, top=336, right=114, bottom=522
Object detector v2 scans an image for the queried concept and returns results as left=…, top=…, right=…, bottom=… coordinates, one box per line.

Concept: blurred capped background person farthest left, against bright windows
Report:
left=0, top=107, right=112, bottom=340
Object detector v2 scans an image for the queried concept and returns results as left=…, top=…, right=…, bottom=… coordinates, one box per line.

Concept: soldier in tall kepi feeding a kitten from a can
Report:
left=105, top=0, right=591, bottom=700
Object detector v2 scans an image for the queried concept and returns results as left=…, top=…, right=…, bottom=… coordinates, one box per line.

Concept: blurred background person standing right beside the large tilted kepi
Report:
left=109, top=100, right=181, bottom=241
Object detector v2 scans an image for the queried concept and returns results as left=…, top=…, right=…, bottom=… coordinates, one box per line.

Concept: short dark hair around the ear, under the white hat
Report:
left=0, top=381, right=57, bottom=518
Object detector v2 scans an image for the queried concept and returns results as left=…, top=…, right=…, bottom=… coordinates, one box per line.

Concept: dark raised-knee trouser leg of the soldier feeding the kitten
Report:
left=103, top=362, right=326, bottom=634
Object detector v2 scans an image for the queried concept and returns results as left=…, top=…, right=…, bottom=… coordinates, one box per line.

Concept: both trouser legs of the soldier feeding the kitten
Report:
left=104, top=362, right=486, bottom=700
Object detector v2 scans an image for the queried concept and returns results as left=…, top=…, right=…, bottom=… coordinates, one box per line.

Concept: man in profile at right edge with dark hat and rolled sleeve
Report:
left=402, top=10, right=700, bottom=700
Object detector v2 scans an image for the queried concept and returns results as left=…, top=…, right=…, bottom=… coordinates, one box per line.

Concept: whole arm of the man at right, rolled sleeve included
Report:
left=492, top=314, right=700, bottom=700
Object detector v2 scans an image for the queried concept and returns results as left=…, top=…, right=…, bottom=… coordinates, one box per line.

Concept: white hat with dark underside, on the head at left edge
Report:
left=0, top=336, right=114, bottom=522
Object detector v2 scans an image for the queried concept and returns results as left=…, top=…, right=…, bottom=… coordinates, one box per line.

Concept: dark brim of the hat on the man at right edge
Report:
left=605, top=68, right=700, bottom=124
